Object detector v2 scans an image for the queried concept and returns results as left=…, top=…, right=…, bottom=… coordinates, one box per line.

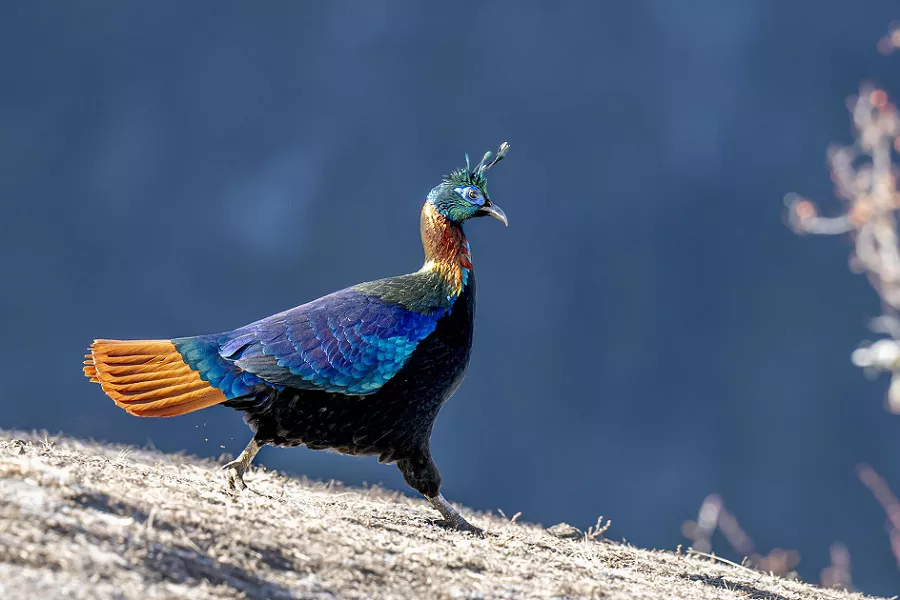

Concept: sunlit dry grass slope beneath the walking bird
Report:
left=0, top=431, right=884, bottom=600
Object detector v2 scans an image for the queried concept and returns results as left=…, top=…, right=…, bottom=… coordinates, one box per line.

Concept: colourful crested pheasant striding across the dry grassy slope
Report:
left=84, top=142, right=509, bottom=535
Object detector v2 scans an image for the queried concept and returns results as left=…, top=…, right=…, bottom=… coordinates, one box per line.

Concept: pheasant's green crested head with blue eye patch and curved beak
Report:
left=427, top=142, right=509, bottom=225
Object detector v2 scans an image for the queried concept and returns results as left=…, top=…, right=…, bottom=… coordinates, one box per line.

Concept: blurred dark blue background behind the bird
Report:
left=0, top=0, right=900, bottom=594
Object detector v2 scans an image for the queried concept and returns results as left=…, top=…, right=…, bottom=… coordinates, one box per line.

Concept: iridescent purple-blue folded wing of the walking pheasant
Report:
left=219, top=288, right=441, bottom=395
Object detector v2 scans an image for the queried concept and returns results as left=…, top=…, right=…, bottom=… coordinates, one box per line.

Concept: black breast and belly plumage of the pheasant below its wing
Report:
left=226, top=274, right=475, bottom=462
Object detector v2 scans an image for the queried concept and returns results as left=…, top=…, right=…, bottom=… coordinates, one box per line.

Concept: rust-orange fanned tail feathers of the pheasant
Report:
left=84, top=340, right=226, bottom=417
